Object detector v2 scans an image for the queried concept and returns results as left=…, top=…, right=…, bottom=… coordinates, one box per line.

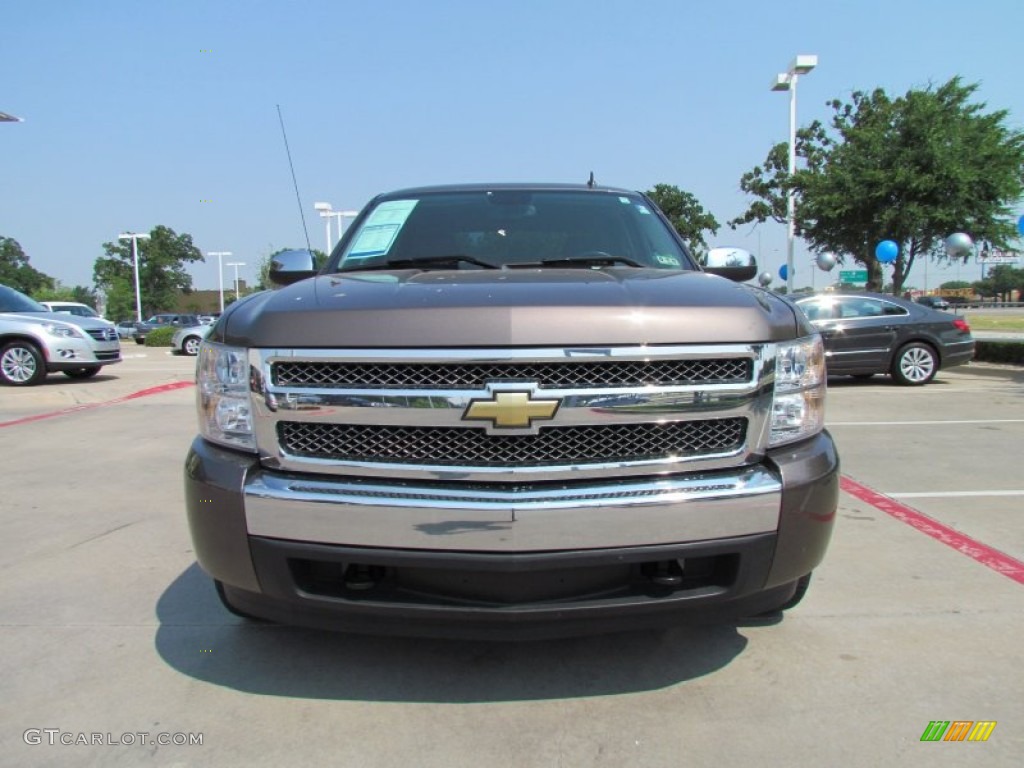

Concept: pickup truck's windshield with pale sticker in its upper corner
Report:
left=328, top=189, right=696, bottom=271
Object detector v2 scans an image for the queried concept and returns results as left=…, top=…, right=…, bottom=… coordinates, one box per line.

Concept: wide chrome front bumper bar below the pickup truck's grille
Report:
left=245, top=467, right=781, bottom=552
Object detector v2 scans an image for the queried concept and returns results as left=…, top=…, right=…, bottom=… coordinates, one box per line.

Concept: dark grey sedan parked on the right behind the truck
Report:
left=793, top=293, right=974, bottom=386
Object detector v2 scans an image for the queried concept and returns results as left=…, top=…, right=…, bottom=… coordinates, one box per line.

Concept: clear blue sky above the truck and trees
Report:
left=0, top=0, right=1024, bottom=296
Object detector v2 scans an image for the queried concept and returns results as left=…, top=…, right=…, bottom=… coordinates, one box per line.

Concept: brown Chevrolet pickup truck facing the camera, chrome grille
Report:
left=185, top=184, right=839, bottom=639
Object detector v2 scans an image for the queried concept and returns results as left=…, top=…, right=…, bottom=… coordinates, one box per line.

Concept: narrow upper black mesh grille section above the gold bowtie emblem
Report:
left=272, top=357, right=753, bottom=389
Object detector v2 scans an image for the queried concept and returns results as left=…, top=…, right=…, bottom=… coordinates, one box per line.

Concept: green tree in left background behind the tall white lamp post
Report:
left=92, top=225, right=205, bottom=317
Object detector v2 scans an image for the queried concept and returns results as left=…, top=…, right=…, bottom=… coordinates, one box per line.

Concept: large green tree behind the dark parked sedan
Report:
left=729, top=78, right=1024, bottom=294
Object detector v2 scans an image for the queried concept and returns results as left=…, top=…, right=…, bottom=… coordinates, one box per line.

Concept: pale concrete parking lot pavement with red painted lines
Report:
left=0, top=352, right=1024, bottom=768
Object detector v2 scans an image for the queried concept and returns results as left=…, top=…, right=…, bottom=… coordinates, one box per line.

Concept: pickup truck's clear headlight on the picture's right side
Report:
left=768, top=335, right=825, bottom=447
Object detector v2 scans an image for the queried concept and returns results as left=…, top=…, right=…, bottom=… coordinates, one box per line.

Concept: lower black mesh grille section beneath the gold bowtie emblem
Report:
left=278, top=418, right=746, bottom=467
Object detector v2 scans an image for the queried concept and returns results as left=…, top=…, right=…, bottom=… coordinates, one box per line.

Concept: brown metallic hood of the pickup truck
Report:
left=218, top=268, right=807, bottom=348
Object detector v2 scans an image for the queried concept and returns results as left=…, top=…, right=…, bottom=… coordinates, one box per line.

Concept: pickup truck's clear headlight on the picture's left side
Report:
left=196, top=341, right=256, bottom=452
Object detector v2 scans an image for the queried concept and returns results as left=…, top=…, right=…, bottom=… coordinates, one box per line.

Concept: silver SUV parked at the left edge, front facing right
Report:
left=0, top=286, right=121, bottom=387
